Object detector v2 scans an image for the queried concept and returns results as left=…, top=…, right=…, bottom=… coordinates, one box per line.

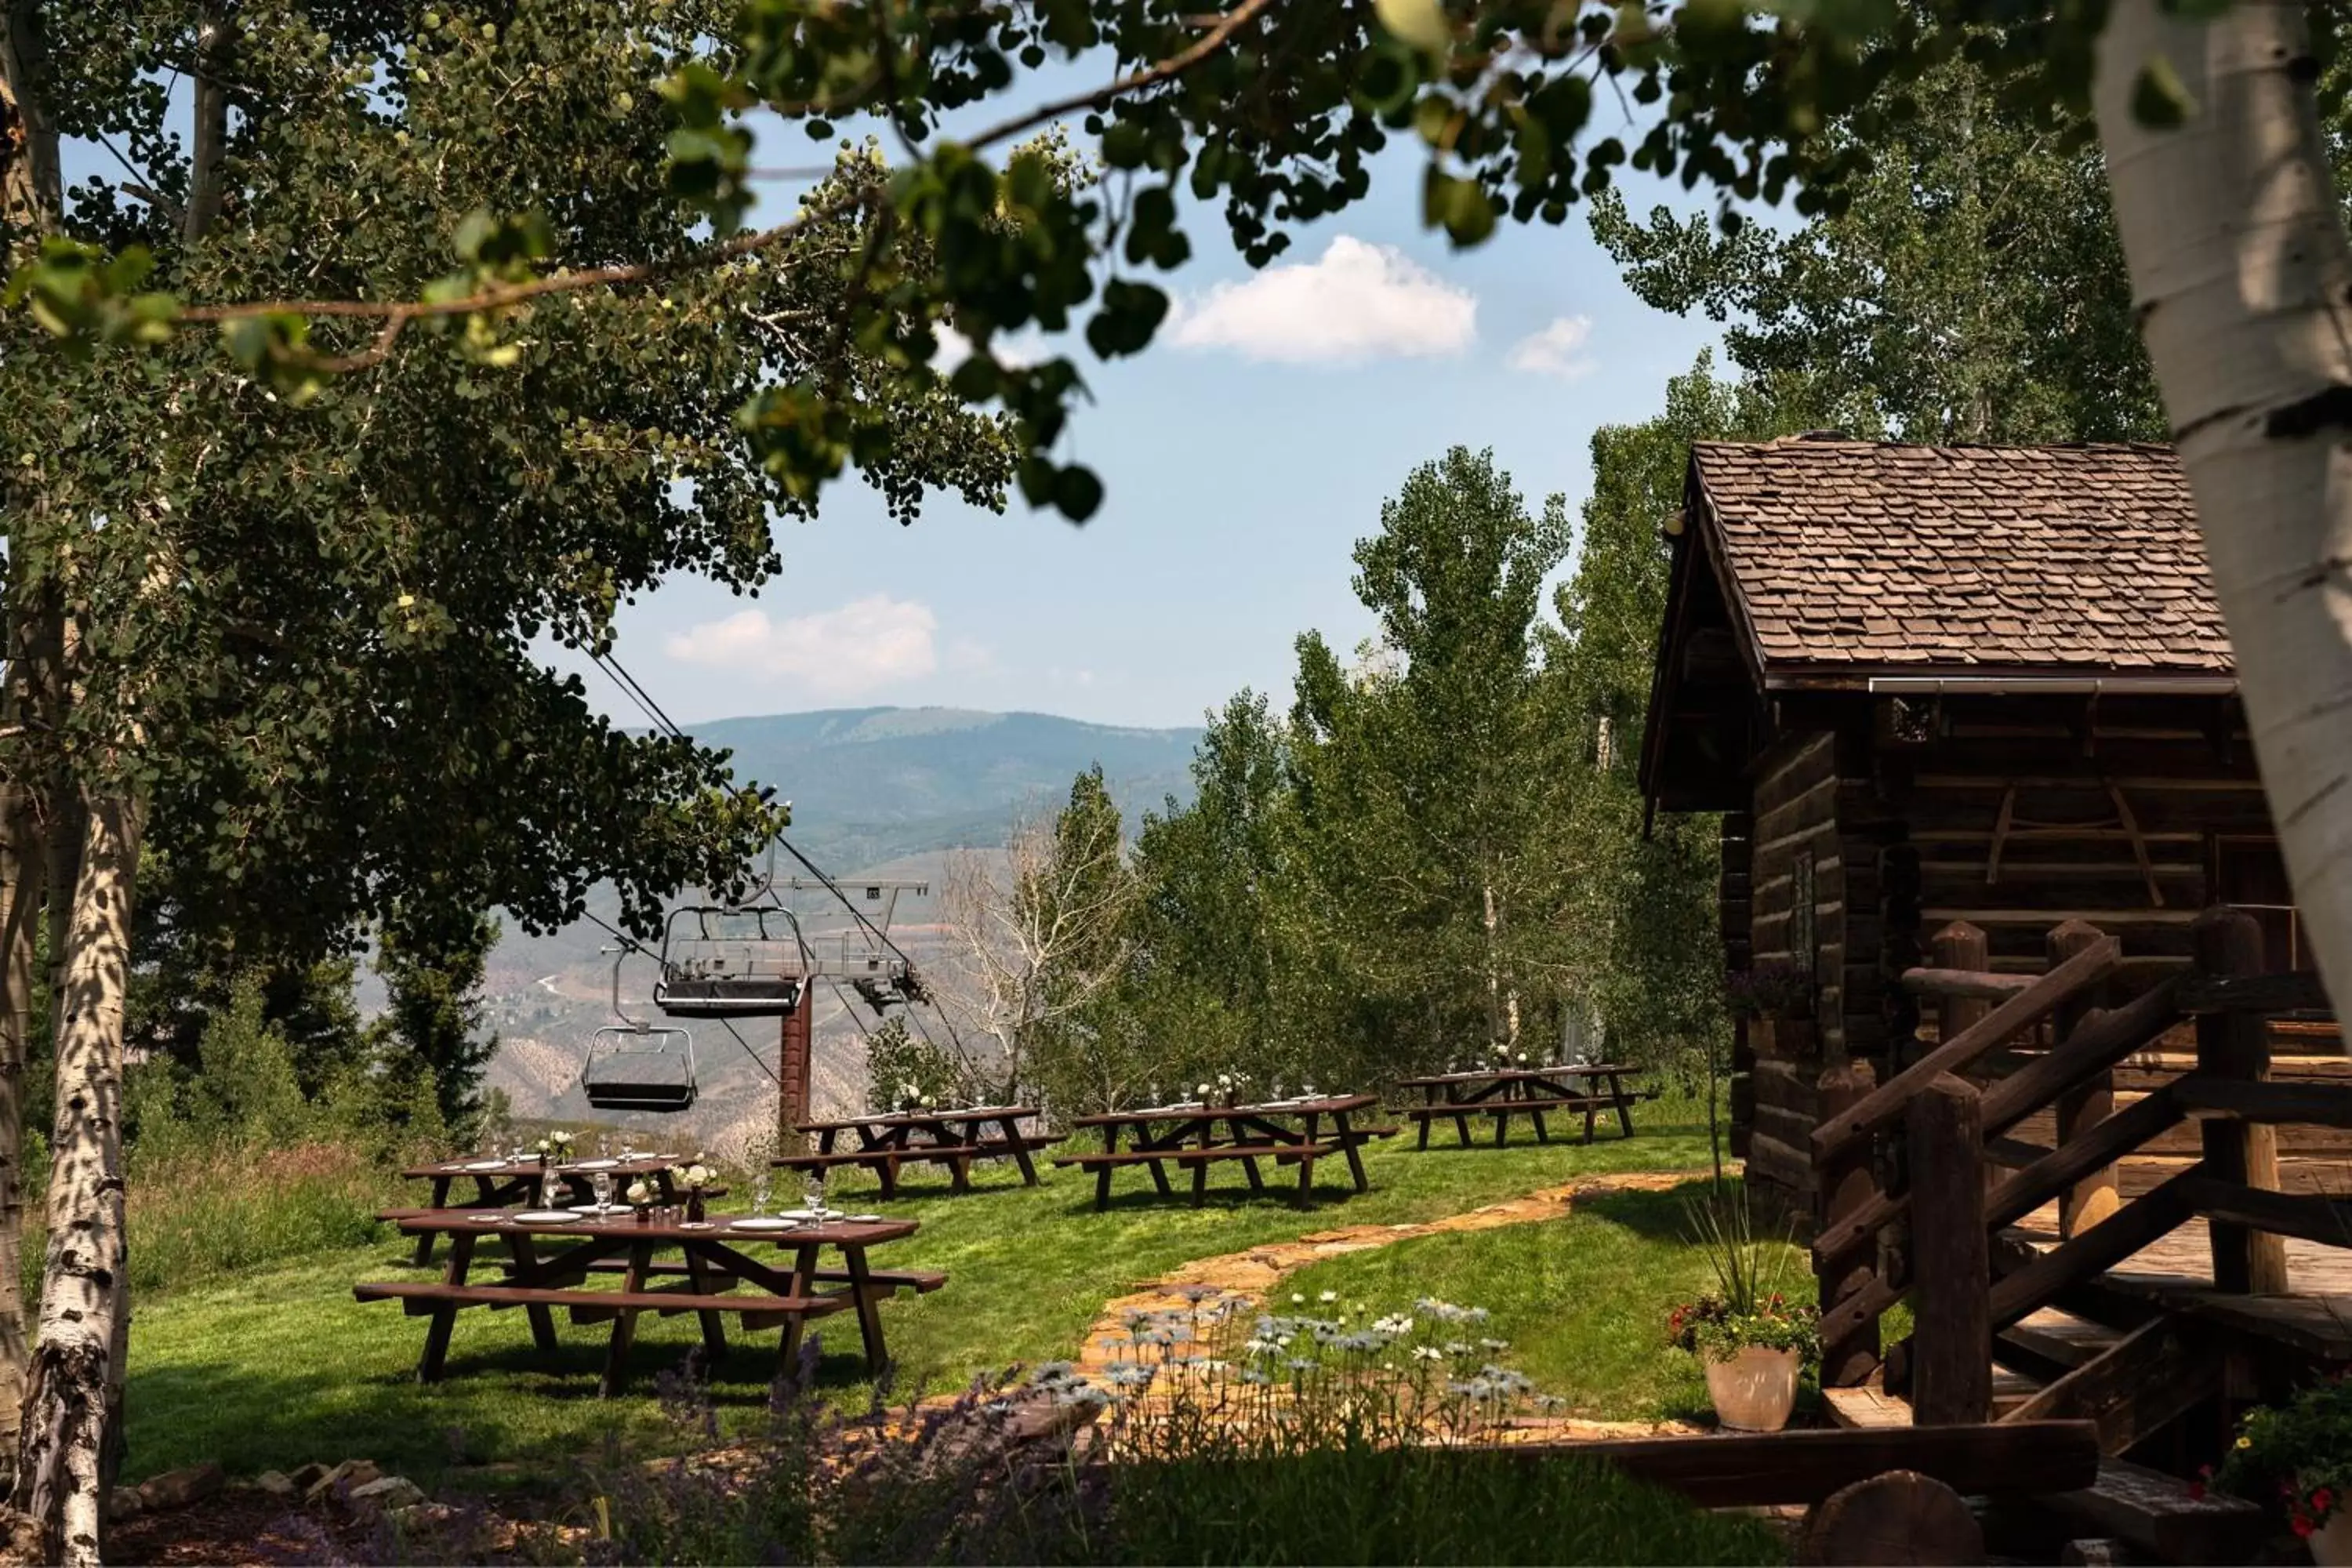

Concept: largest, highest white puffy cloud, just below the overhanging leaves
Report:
left=1169, top=235, right=1477, bottom=365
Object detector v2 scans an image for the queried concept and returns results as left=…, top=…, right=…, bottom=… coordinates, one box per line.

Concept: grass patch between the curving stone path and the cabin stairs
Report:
left=1289, top=1180, right=1813, bottom=1420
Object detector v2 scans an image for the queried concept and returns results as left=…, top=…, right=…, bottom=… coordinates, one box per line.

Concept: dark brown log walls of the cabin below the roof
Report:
left=1722, top=694, right=2319, bottom=1215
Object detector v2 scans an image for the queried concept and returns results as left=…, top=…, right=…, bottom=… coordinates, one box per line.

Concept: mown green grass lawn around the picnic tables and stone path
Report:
left=125, top=1107, right=1708, bottom=1483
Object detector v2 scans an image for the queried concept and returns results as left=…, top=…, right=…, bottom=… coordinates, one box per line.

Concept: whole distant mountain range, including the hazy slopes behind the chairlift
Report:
left=485, top=708, right=1202, bottom=1149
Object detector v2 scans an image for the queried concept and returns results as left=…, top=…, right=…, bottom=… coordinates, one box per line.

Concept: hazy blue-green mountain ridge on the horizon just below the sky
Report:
left=691, top=708, right=1202, bottom=865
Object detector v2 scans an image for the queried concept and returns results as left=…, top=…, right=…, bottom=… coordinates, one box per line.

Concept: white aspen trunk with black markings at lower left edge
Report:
left=14, top=794, right=143, bottom=1566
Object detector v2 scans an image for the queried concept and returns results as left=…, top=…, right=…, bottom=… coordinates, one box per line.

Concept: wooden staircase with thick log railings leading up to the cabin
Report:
left=1813, top=909, right=2352, bottom=1561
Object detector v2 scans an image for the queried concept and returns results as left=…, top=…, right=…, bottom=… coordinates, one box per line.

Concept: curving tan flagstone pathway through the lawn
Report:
left=1077, top=1171, right=1705, bottom=1443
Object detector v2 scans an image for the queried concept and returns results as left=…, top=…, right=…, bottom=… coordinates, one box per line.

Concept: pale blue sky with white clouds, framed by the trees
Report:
left=66, top=66, right=1719, bottom=729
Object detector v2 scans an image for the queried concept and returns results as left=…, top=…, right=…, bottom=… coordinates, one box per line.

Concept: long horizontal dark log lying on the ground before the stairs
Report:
left=1486, top=1420, right=2098, bottom=1507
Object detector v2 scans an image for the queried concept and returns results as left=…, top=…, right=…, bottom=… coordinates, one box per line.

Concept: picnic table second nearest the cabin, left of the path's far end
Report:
left=1054, top=1095, right=1397, bottom=1208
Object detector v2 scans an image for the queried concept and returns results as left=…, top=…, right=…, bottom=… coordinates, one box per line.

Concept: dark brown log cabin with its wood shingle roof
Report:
left=1639, top=433, right=2343, bottom=1215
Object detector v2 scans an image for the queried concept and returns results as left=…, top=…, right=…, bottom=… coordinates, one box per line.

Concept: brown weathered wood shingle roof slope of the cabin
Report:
left=1691, top=435, right=2234, bottom=675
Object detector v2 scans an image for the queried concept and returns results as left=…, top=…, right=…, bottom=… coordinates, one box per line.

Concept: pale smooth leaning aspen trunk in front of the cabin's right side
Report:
left=2096, top=0, right=2352, bottom=1048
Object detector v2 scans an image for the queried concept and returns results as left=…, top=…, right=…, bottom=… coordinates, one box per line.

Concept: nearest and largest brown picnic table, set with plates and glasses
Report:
left=353, top=1208, right=927, bottom=1396
